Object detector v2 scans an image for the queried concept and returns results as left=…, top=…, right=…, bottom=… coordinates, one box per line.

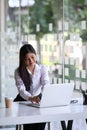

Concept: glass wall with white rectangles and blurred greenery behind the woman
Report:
left=0, top=0, right=87, bottom=129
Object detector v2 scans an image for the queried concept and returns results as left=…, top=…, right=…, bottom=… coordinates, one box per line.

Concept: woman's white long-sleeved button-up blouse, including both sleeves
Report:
left=15, top=64, right=49, bottom=100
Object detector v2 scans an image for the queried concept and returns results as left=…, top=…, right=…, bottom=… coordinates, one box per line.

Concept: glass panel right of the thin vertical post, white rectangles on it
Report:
left=64, top=0, right=87, bottom=90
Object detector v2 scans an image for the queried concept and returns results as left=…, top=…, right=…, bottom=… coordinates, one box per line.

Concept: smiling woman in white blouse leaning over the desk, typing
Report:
left=14, top=44, right=49, bottom=130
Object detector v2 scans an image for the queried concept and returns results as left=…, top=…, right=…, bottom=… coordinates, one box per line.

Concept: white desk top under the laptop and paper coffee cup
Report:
left=0, top=102, right=87, bottom=126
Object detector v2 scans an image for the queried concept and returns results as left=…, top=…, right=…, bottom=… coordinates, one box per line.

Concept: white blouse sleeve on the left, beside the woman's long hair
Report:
left=14, top=69, right=31, bottom=100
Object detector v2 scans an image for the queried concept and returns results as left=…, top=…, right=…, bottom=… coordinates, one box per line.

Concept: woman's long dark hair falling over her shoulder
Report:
left=18, top=44, right=36, bottom=91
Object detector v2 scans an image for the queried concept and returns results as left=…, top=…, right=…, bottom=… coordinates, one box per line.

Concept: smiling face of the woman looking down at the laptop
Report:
left=25, top=53, right=37, bottom=67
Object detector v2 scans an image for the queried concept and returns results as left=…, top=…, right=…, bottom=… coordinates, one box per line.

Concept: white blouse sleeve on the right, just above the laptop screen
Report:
left=41, top=65, right=50, bottom=86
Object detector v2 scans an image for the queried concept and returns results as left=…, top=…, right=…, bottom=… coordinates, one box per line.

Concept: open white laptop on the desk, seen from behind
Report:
left=29, top=83, right=74, bottom=108
